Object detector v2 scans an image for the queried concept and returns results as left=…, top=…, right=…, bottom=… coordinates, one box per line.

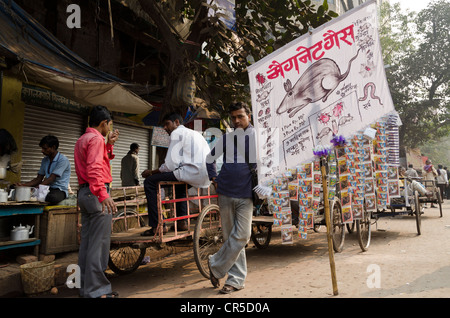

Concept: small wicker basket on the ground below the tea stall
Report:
left=20, top=262, right=55, bottom=294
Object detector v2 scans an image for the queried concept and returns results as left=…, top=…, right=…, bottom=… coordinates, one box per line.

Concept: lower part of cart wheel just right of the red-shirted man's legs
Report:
left=108, top=245, right=147, bottom=275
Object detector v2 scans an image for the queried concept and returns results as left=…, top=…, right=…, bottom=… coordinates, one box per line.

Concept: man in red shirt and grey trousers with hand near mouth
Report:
left=74, top=106, right=119, bottom=298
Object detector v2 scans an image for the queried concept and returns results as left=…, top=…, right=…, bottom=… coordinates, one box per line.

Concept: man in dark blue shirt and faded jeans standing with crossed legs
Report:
left=207, top=102, right=256, bottom=294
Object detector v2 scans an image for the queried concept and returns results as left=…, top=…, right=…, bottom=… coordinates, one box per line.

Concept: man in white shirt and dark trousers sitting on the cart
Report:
left=142, top=113, right=210, bottom=236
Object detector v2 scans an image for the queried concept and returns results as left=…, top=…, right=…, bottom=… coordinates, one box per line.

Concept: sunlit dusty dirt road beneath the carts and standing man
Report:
left=54, top=202, right=450, bottom=299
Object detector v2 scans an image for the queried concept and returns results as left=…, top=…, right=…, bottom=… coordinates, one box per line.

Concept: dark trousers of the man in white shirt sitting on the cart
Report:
left=144, top=172, right=187, bottom=229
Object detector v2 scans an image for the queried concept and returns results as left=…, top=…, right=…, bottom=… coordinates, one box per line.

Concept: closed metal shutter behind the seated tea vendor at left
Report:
left=21, top=105, right=84, bottom=191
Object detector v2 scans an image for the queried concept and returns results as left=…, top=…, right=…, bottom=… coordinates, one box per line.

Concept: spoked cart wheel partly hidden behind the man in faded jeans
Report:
left=194, top=204, right=223, bottom=279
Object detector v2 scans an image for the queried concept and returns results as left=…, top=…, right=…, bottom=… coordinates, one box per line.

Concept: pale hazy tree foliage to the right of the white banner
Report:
left=381, top=0, right=450, bottom=148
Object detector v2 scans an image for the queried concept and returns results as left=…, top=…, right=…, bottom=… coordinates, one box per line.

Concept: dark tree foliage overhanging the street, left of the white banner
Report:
left=139, top=0, right=337, bottom=114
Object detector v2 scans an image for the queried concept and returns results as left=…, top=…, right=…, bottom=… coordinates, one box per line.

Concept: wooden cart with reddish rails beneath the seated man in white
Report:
left=101, top=182, right=223, bottom=278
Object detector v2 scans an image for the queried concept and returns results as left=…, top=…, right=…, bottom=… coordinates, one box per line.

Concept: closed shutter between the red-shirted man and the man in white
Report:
left=111, top=121, right=151, bottom=187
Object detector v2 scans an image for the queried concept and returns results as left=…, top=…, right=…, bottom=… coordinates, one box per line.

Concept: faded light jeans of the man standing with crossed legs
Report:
left=209, top=194, right=253, bottom=289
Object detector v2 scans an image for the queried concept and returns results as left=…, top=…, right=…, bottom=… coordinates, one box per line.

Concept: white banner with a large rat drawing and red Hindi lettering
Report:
left=249, top=1, right=395, bottom=182
